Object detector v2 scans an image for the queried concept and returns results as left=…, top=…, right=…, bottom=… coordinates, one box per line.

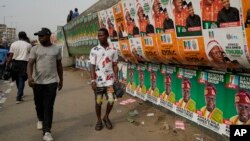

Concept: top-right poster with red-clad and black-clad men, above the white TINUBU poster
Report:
left=201, top=0, right=241, bottom=29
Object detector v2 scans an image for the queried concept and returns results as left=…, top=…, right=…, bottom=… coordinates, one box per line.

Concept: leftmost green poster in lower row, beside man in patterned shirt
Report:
left=126, top=63, right=138, bottom=96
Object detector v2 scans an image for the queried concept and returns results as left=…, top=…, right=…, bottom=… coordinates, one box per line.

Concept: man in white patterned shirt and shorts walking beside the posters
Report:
left=89, top=28, right=118, bottom=131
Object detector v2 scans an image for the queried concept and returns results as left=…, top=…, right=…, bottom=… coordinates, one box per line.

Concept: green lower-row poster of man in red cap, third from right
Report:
left=176, top=68, right=198, bottom=121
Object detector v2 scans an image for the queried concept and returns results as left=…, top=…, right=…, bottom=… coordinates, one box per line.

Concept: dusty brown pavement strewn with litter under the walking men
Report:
left=0, top=69, right=229, bottom=141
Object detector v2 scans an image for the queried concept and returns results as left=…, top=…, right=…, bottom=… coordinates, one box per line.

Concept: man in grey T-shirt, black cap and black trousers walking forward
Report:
left=28, top=28, right=63, bottom=141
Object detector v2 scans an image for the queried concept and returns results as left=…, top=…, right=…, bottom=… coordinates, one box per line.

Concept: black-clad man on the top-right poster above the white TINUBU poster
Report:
left=217, top=0, right=240, bottom=26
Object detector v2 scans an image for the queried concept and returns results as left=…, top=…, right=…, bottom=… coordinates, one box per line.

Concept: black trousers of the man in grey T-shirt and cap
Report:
left=33, top=83, right=57, bottom=133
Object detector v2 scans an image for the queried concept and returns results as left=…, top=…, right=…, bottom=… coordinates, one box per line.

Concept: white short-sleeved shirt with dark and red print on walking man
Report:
left=89, top=44, right=118, bottom=87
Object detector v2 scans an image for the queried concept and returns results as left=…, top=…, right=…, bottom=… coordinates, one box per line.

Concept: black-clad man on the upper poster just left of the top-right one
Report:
left=186, top=2, right=201, bottom=28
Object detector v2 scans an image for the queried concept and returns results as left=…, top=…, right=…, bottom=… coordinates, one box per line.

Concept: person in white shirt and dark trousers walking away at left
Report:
left=6, top=31, right=32, bottom=104
